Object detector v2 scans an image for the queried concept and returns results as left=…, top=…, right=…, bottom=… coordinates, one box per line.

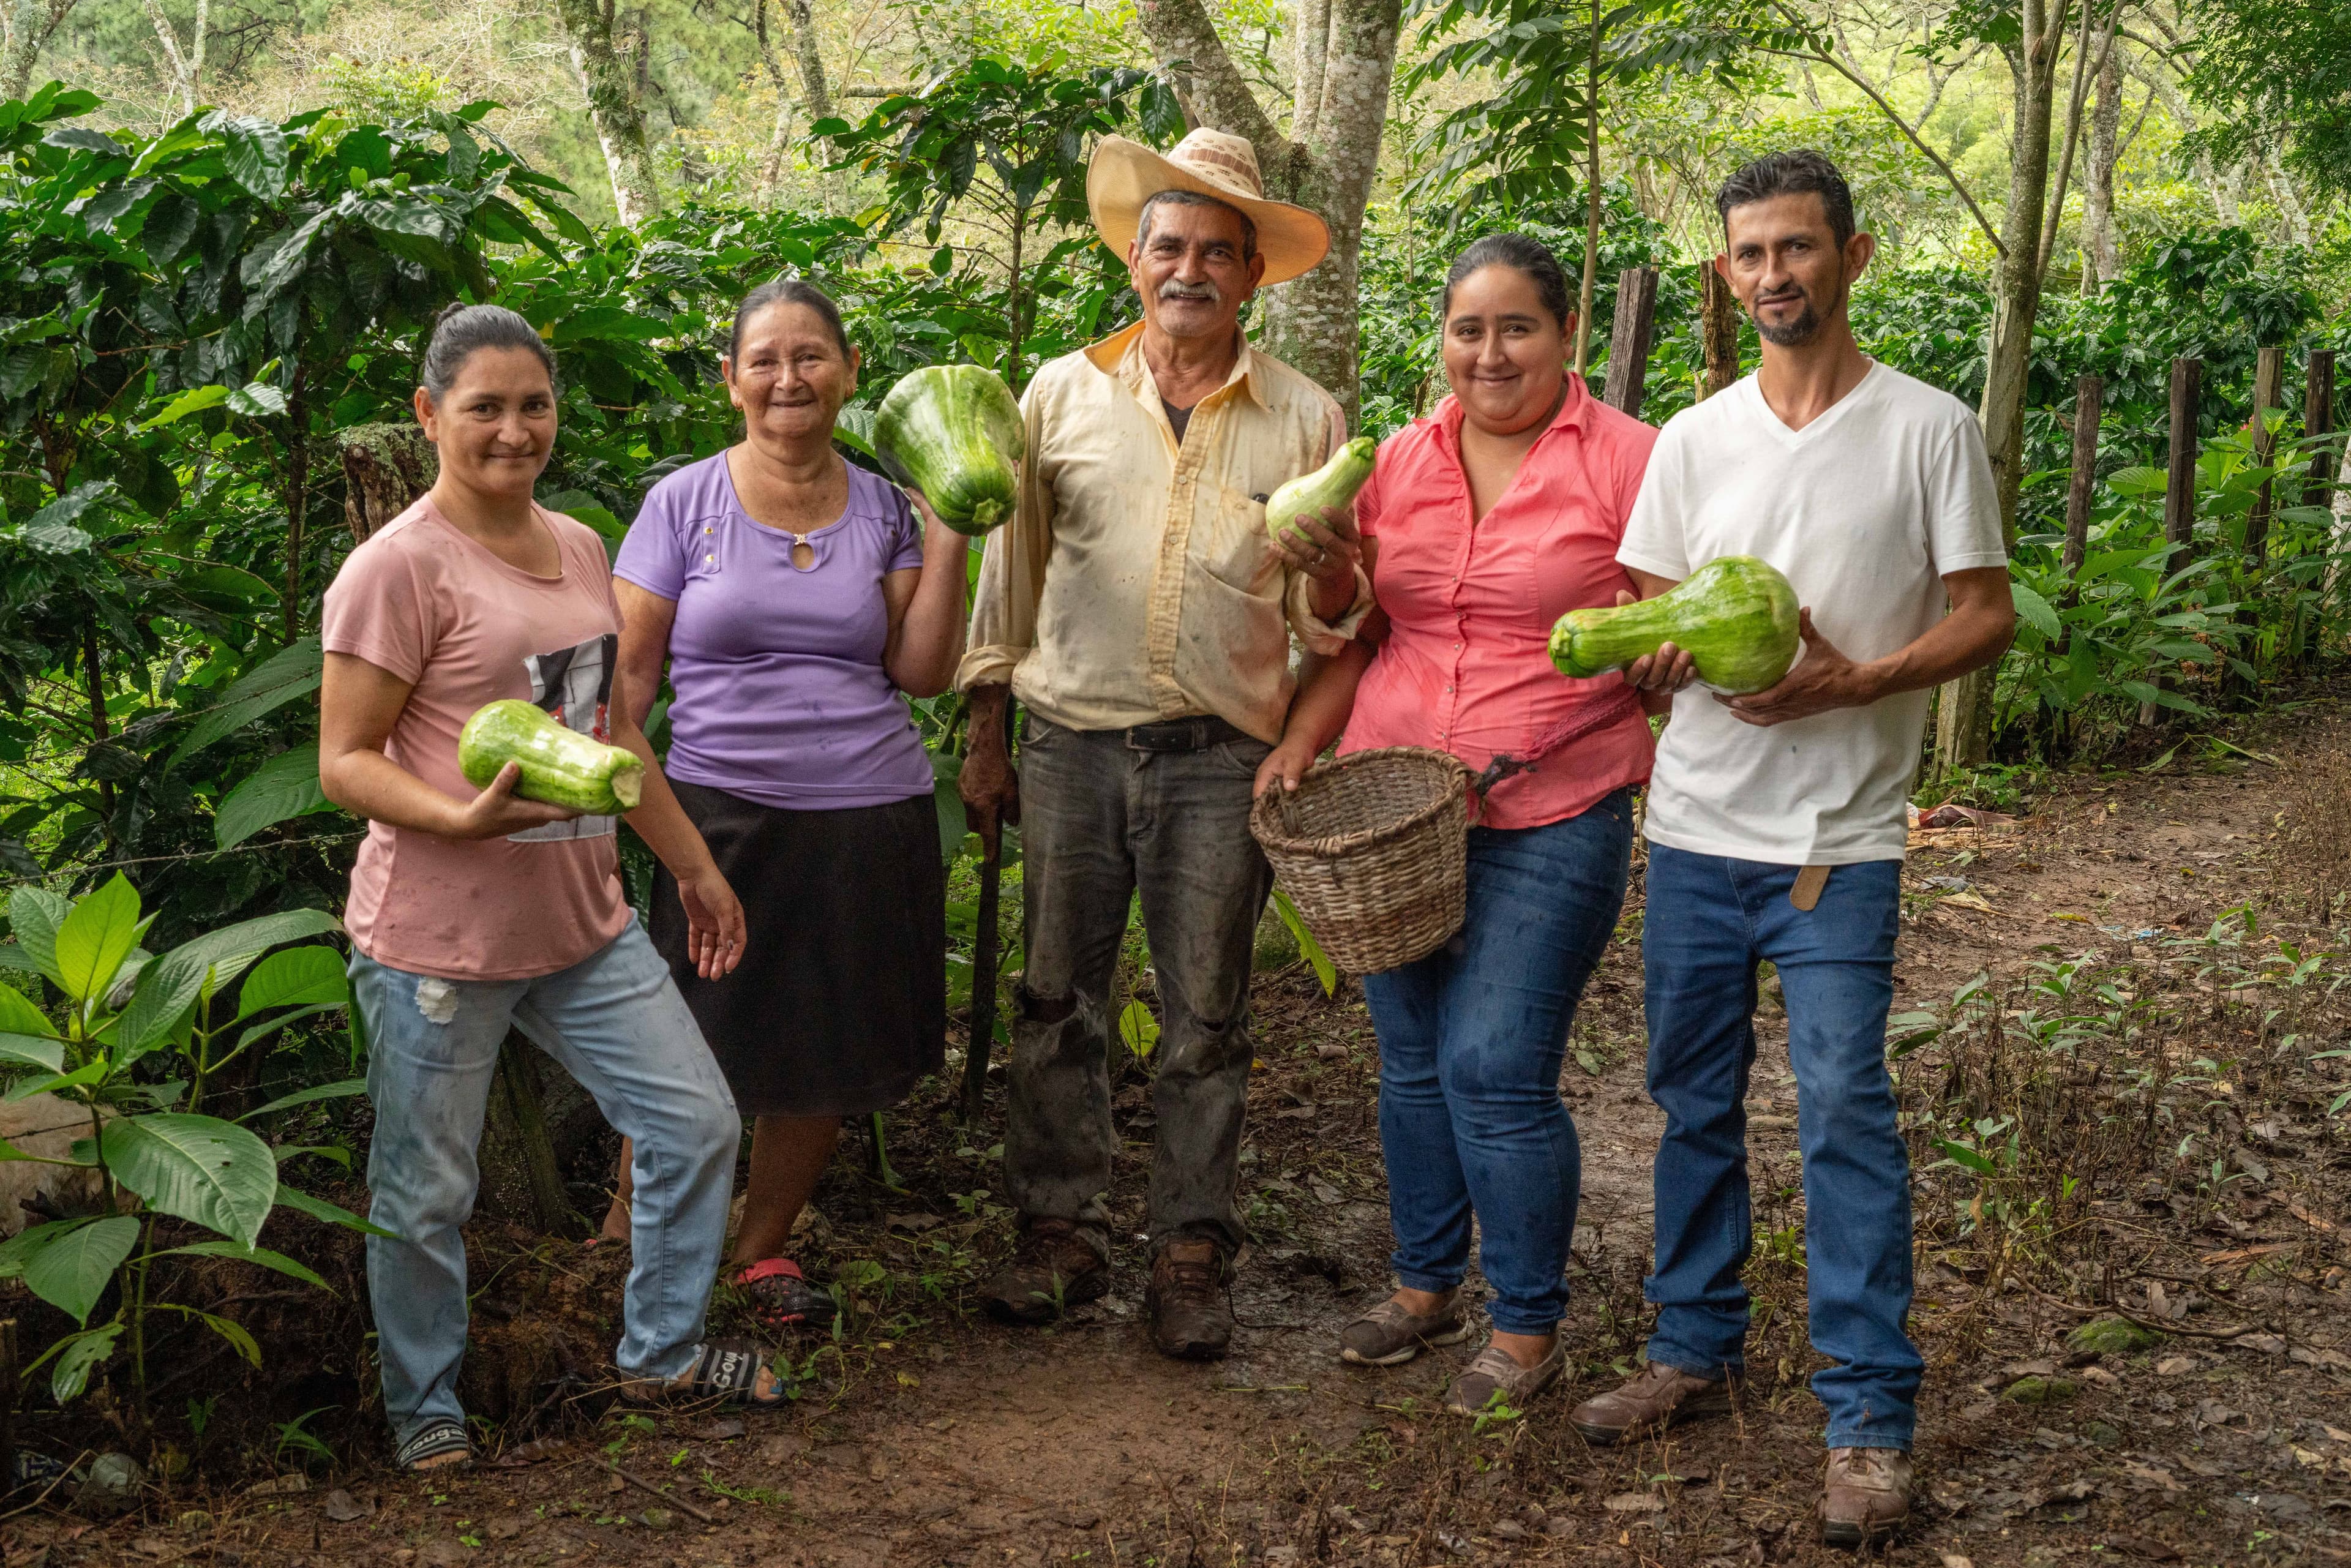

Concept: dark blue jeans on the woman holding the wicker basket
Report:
left=1363, top=790, right=1632, bottom=1335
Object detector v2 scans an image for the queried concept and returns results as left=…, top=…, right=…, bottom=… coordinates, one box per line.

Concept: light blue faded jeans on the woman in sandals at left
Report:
left=350, top=919, right=743, bottom=1444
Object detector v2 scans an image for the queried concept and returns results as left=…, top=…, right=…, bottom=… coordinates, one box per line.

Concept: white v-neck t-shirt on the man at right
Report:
left=1618, top=364, right=2008, bottom=865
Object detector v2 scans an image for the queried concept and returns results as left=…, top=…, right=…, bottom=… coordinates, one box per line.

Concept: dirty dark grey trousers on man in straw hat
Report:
left=1004, top=715, right=1272, bottom=1258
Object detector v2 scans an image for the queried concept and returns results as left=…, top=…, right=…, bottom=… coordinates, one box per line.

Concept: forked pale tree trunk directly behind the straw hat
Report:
left=1138, top=0, right=1401, bottom=428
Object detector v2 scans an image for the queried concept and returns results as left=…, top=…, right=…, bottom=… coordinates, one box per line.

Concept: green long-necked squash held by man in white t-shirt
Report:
left=1551, top=555, right=1799, bottom=694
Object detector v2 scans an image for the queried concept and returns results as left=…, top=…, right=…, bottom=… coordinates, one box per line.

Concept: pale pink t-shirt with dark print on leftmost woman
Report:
left=324, top=496, right=630, bottom=980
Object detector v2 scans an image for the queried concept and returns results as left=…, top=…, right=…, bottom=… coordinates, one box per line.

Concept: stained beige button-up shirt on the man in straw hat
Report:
left=954, top=324, right=1371, bottom=743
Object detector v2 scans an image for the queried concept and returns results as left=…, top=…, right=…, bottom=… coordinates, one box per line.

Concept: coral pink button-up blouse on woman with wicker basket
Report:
left=1340, top=373, right=1657, bottom=828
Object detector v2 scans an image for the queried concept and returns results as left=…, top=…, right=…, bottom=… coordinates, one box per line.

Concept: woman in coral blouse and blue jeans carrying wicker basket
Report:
left=1258, top=235, right=1657, bottom=1415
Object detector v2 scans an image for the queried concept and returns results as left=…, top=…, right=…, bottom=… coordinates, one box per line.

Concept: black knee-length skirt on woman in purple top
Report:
left=654, top=778, right=948, bottom=1117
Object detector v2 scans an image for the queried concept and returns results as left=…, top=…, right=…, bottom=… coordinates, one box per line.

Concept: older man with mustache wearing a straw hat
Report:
left=957, top=129, right=1371, bottom=1359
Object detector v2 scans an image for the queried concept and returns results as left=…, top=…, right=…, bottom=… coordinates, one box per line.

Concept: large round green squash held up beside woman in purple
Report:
left=872, top=364, right=1027, bottom=534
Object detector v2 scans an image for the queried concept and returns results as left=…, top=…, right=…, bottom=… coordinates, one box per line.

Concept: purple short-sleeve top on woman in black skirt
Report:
left=613, top=451, right=931, bottom=811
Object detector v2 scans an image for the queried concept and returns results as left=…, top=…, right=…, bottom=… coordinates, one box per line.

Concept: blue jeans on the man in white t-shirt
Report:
left=1641, top=844, right=1923, bottom=1448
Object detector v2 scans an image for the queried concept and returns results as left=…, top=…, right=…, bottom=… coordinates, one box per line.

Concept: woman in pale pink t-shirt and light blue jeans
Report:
left=320, top=306, right=783, bottom=1469
